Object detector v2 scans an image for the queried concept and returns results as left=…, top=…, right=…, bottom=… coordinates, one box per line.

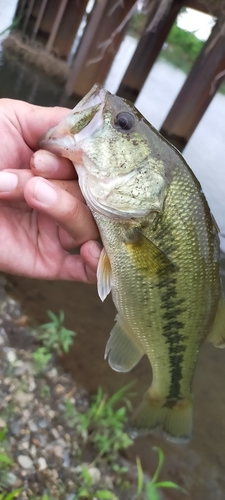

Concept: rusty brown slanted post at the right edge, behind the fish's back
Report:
left=160, top=17, right=225, bottom=151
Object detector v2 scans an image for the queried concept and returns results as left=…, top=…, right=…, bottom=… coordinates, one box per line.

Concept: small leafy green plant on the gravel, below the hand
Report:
left=37, top=310, right=76, bottom=355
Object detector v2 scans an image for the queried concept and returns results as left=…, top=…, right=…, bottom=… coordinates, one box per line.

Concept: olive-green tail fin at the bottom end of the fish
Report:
left=131, top=391, right=193, bottom=443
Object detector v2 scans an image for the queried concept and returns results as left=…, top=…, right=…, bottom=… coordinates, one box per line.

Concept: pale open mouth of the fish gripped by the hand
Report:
left=39, top=85, right=109, bottom=161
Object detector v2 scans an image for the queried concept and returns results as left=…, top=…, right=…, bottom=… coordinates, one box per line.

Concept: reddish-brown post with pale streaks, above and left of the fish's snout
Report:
left=66, top=0, right=136, bottom=97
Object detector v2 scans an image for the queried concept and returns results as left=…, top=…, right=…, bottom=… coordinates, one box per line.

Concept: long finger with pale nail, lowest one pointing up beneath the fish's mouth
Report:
left=24, top=177, right=99, bottom=246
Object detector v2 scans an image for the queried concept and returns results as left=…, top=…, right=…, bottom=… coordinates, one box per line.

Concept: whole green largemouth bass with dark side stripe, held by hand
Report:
left=40, top=85, right=225, bottom=443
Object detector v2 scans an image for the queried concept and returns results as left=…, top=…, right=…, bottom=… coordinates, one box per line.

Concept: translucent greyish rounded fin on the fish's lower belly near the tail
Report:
left=105, top=315, right=144, bottom=372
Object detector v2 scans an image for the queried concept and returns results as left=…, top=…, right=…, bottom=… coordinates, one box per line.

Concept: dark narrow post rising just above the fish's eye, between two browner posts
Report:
left=117, top=0, right=183, bottom=102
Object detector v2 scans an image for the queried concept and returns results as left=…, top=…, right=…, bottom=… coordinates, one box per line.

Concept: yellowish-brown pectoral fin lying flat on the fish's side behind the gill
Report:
left=125, top=229, right=176, bottom=275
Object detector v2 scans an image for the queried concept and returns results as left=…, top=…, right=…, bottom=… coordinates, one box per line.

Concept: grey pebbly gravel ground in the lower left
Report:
left=0, top=277, right=154, bottom=500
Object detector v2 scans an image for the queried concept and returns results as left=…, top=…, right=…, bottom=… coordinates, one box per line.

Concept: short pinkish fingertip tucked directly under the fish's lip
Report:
left=30, top=149, right=77, bottom=180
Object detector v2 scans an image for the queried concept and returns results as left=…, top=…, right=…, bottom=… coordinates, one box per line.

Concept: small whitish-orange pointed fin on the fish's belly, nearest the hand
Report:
left=97, top=248, right=112, bottom=302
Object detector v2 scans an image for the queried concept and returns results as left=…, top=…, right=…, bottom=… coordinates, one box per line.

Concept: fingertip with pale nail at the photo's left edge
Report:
left=0, top=169, right=33, bottom=201
